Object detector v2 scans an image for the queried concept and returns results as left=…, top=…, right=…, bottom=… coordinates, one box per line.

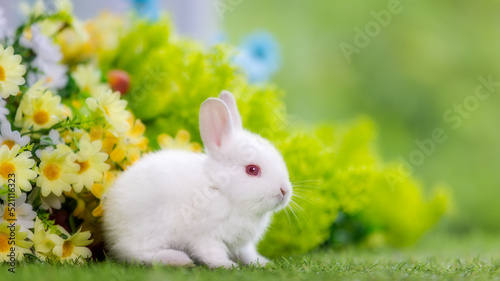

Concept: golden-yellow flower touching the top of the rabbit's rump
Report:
left=103, top=116, right=148, bottom=168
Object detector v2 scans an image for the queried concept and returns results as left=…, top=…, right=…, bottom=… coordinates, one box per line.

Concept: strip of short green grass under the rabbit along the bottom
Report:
left=0, top=230, right=500, bottom=281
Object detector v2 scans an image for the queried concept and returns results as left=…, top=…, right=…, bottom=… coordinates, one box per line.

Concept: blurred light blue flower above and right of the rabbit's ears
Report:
left=234, top=31, right=281, bottom=83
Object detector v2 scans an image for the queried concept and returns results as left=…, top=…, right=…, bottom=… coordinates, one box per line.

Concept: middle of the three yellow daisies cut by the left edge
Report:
left=0, top=144, right=36, bottom=196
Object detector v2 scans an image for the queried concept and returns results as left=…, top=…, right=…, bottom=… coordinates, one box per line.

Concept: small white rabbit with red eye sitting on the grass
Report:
left=103, top=91, right=292, bottom=268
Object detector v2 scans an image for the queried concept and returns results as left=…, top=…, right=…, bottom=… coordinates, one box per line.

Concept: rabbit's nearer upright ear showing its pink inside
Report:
left=200, top=98, right=234, bottom=151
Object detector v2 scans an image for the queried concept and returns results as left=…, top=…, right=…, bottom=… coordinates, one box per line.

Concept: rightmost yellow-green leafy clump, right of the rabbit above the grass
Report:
left=359, top=170, right=450, bottom=246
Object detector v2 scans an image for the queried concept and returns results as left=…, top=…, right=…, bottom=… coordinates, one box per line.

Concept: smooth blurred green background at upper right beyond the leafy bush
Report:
left=222, top=0, right=500, bottom=233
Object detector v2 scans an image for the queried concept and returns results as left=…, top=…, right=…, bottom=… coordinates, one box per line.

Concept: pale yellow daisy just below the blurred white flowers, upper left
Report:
left=14, top=88, right=65, bottom=131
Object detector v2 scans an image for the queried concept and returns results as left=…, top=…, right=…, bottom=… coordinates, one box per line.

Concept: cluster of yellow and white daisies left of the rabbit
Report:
left=0, top=2, right=152, bottom=263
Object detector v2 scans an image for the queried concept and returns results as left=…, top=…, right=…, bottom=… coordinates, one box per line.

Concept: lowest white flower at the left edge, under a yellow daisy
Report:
left=0, top=193, right=36, bottom=230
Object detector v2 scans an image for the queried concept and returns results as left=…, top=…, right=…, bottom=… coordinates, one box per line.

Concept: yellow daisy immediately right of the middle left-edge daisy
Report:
left=36, top=148, right=80, bottom=197
